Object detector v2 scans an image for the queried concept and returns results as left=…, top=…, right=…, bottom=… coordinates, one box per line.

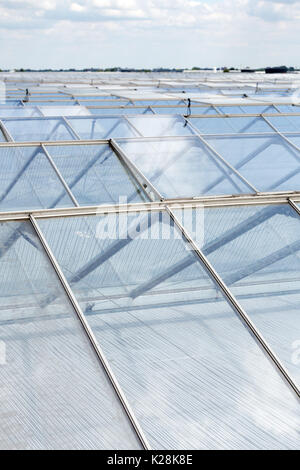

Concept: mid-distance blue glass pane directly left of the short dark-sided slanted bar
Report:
left=47, top=145, right=145, bottom=206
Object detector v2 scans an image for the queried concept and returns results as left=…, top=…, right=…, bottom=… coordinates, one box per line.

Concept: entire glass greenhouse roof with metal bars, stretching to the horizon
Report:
left=0, top=73, right=300, bottom=449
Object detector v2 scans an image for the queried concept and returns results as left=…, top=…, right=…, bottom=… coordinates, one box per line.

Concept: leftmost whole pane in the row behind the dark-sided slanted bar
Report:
left=4, top=118, right=75, bottom=142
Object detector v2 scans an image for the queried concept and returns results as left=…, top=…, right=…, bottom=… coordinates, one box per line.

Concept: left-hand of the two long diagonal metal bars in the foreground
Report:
left=30, top=215, right=151, bottom=450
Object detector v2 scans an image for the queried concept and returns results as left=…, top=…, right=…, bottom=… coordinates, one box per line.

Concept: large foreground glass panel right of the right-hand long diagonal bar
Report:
left=184, top=205, right=300, bottom=386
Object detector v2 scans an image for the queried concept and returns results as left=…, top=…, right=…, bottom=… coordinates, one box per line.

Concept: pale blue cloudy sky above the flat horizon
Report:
left=0, top=0, right=300, bottom=69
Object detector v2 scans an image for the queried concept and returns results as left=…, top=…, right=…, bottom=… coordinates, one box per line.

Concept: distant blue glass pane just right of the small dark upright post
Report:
left=191, top=116, right=274, bottom=134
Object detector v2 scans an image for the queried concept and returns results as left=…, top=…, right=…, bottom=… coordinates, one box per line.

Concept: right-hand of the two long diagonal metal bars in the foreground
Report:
left=166, top=206, right=300, bottom=398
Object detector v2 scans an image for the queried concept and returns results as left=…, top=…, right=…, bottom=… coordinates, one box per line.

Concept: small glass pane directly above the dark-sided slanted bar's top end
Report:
left=68, top=117, right=138, bottom=140
